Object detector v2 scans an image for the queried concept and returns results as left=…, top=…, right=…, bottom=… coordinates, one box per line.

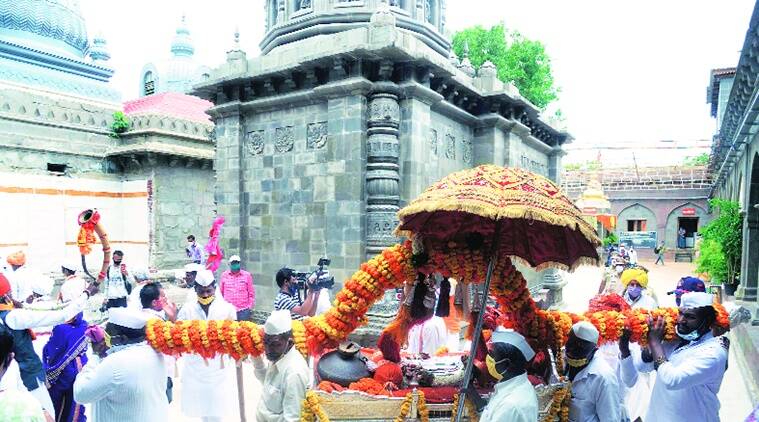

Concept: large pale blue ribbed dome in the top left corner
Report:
left=0, top=0, right=89, bottom=60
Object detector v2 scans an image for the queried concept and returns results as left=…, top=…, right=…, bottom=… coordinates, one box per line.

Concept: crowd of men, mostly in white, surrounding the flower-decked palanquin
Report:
left=0, top=242, right=748, bottom=422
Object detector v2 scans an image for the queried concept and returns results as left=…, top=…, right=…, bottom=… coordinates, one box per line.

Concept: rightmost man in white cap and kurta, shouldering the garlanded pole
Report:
left=620, top=292, right=728, bottom=422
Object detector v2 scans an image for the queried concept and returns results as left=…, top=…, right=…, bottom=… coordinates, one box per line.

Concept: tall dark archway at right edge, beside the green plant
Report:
left=736, top=154, right=759, bottom=301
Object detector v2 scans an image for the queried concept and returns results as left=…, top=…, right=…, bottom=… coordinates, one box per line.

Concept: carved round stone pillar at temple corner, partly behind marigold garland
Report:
left=356, top=79, right=400, bottom=345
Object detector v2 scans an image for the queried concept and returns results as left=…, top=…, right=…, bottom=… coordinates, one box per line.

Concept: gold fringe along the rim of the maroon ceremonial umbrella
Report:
left=395, top=198, right=601, bottom=247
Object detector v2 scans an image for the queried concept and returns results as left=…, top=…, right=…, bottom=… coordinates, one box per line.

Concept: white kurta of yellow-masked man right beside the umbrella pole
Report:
left=480, top=374, right=538, bottom=422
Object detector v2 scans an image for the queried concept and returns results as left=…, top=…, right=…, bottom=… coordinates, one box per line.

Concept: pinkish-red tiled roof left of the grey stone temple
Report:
left=124, top=92, right=213, bottom=123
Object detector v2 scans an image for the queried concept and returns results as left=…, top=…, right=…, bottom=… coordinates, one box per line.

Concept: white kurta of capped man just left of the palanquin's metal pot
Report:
left=253, top=347, right=310, bottom=422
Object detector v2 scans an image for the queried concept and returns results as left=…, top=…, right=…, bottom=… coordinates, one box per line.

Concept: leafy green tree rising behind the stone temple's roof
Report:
left=453, top=24, right=558, bottom=109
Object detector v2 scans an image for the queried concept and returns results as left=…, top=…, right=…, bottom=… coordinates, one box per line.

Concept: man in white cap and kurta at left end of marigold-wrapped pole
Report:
left=74, top=307, right=169, bottom=422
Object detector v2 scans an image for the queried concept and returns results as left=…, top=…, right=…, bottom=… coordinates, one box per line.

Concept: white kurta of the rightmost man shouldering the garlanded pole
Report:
left=622, top=333, right=727, bottom=422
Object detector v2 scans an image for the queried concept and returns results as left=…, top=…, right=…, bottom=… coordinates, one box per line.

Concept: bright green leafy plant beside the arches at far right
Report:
left=696, top=198, right=743, bottom=284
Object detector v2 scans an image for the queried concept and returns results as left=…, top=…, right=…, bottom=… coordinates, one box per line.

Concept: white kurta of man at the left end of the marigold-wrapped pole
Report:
left=74, top=342, right=169, bottom=422
